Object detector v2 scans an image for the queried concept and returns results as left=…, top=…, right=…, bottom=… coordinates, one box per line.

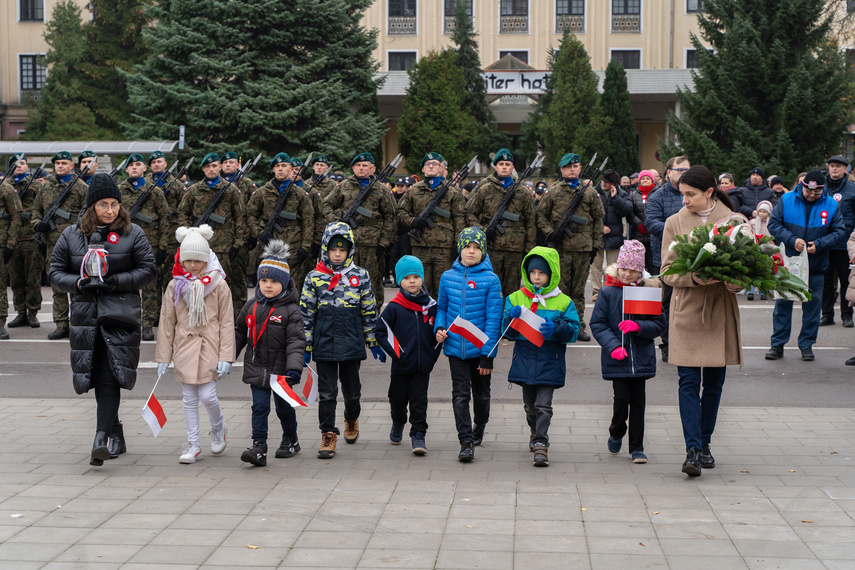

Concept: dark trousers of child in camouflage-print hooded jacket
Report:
left=315, top=360, right=362, bottom=434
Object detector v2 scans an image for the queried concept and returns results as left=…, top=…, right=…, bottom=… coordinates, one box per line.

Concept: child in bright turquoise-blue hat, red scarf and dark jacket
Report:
left=377, top=255, right=440, bottom=455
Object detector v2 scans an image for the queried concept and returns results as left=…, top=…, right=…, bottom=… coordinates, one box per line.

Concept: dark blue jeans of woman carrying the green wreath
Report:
left=677, top=366, right=727, bottom=452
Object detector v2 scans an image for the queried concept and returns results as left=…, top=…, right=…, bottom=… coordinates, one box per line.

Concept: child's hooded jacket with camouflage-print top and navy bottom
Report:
left=300, top=222, right=377, bottom=362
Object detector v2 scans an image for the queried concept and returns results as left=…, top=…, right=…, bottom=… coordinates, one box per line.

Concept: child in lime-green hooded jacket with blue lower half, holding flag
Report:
left=503, top=247, right=579, bottom=467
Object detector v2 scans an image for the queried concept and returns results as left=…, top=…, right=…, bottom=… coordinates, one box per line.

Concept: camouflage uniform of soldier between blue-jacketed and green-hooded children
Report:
left=466, top=172, right=537, bottom=296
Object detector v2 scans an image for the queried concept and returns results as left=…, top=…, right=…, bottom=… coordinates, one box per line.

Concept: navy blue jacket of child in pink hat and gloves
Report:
left=589, top=265, right=665, bottom=380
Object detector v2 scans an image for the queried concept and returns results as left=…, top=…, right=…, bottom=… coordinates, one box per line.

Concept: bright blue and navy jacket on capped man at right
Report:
left=768, top=184, right=849, bottom=275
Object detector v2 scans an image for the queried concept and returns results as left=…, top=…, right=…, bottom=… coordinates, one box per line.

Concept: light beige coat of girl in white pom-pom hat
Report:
left=154, top=279, right=235, bottom=384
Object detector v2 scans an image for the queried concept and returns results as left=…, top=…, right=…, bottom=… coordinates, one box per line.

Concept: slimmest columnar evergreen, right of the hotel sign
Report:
left=602, top=60, right=641, bottom=175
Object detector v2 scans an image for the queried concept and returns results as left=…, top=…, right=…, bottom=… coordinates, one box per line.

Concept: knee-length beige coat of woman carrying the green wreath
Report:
left=662, top=202, right=743, bottom=368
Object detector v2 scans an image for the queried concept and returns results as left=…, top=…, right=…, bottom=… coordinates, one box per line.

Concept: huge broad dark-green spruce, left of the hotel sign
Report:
left=126, top=0, right=383, bottom=166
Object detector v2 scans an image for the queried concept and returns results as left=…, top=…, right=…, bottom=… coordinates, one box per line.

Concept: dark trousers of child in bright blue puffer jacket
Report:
left=448, top=356, right=492, bottom=444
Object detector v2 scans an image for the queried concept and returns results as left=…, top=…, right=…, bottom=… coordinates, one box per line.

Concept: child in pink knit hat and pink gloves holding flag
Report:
left=591, top=240, right=665, bottom=463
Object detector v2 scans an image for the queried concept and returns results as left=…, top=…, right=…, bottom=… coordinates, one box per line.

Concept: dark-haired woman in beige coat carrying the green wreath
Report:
left=662, top=166, right=742, bottom=476
